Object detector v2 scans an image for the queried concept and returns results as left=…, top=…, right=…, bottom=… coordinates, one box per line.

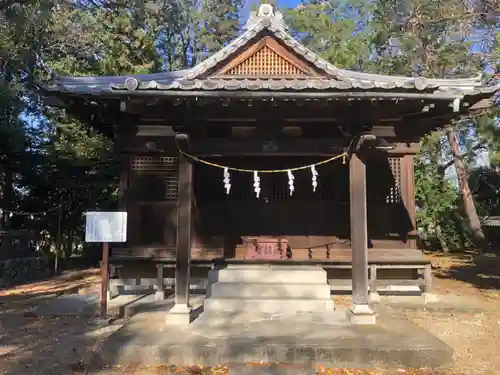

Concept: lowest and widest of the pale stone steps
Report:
left=203, top=297, right=334, bottom=314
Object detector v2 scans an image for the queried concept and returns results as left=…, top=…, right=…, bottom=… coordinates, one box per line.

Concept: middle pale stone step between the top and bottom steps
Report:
left=209, top=282, right=330, bottom=299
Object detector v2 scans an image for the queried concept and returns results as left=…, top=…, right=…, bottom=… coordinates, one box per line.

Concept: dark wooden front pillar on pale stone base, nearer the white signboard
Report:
left=167, top=154, right=193, bottom=325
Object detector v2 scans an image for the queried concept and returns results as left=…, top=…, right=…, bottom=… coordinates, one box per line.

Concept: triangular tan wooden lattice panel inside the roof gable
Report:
left=225, top=46, right=306, bottom=76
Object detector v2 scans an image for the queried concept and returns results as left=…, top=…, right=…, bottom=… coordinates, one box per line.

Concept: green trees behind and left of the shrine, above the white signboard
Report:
left=0, top=0, right=245, bottom=262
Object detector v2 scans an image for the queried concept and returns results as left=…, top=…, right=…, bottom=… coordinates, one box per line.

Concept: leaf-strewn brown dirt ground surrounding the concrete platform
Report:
left=0, top=254, right=500, bottom=375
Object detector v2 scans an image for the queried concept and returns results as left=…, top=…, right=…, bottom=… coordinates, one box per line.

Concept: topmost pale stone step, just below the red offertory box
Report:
left=210, top=267, right=327, bottom=284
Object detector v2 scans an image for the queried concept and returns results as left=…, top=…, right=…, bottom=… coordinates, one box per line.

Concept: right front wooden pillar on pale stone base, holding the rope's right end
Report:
left=349, top=153, right=375, bottom=324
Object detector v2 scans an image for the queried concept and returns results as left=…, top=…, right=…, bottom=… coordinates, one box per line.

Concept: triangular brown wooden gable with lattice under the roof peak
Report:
left=212, top=35, right=323, bottom=78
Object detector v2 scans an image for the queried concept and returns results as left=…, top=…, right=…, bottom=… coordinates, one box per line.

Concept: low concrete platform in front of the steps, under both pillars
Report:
left=94, top=309, right=452, bottom=368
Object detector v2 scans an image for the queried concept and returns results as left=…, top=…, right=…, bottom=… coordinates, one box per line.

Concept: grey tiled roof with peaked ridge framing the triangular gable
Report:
left=36, top=4, right=500, bottom=110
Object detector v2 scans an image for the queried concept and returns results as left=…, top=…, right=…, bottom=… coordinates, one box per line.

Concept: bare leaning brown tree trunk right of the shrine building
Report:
left=446, top=126, right=489, bottom=252
